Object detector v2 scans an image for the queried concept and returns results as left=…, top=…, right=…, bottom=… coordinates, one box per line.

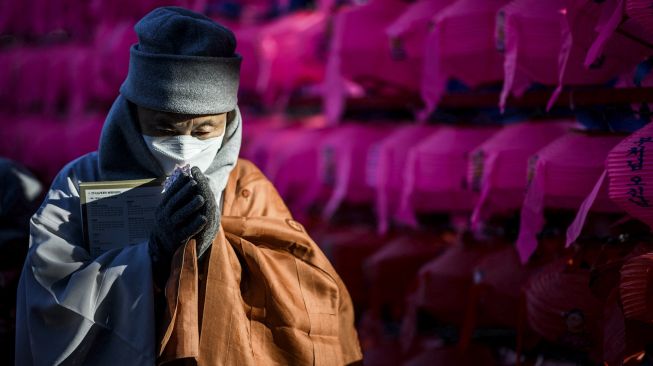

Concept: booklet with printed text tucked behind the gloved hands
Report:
left=79, top=179, right=163, bottom=257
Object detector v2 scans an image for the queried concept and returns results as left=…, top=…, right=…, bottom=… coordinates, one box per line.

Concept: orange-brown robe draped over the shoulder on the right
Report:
left=158, top=160, right=362, bottom=366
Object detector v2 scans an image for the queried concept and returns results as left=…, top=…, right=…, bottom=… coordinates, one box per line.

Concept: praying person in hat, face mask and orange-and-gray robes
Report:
left=16, top=7, right=362, bottom=366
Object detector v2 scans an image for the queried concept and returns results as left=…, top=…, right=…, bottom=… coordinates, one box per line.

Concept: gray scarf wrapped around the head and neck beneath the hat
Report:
left=98, top=95, right=242, bottom=197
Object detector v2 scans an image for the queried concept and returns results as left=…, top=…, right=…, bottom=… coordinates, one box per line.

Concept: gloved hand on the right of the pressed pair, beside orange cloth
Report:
left=190, top=167, right=220, bottom=258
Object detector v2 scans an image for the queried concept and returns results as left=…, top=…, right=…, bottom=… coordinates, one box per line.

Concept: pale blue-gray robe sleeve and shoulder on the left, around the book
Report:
left=16, top=156, right=155, bottom=365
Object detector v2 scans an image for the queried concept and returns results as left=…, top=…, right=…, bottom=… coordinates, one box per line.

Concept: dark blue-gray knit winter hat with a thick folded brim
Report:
left=120, top=7, right=242, bottom=114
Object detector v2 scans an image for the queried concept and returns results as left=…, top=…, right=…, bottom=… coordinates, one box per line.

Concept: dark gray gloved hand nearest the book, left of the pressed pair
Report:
left=148, top=174, right=208, bottom=288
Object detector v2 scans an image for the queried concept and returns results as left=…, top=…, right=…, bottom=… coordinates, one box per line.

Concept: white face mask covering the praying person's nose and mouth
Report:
left=143, top=132, right=224, bottom=175
